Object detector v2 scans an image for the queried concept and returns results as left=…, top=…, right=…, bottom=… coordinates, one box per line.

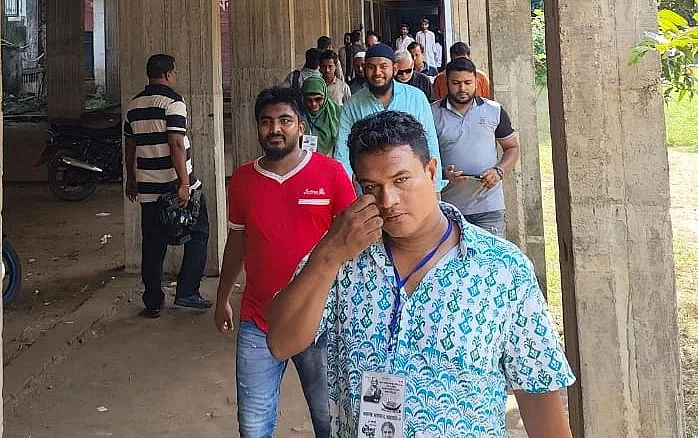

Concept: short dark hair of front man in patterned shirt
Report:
left=348, top=111, right=430, bottom=171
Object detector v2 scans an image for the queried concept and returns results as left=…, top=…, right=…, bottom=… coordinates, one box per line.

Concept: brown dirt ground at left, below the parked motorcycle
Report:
left=3, top=183, right=124, bottom=364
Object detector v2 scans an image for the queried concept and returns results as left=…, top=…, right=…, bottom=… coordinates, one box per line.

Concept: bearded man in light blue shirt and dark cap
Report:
left=334, top=43, right=446, bottom=191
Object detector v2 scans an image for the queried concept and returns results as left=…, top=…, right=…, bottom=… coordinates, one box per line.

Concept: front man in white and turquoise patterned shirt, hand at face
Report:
left=267, top=111, right=575, bottom=438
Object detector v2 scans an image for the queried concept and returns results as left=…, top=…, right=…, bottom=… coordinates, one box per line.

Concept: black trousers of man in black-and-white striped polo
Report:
left=141, top=193, right=208, bottom=309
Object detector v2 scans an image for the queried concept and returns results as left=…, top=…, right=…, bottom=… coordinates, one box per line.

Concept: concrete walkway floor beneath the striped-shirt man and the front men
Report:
left=4, top=277, right=526, bottom=438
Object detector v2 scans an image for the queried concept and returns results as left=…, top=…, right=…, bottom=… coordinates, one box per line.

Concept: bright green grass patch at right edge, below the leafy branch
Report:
left=664, top=96, right=698, bottom=152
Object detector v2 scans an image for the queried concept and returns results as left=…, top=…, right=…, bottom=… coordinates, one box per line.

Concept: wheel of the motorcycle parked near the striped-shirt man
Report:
left=48, top=149, right=97, bottom=201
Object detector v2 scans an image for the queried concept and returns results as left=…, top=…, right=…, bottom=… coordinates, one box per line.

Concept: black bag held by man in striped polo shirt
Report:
left=158, top=190, right=201, bottom=245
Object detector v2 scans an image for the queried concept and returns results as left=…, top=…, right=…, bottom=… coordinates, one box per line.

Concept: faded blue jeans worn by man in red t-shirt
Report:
left=236, top=321, right=330, bottom=438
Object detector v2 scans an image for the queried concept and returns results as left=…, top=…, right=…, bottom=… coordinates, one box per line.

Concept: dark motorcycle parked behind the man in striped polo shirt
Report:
left=35, top=124, right=123, bottom=201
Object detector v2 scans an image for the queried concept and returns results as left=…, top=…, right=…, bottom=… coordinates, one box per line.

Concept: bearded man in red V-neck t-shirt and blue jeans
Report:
left=215, top=88, right=355, bottom=438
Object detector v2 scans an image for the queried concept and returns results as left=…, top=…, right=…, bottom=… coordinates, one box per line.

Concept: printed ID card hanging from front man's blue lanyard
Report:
left=358, top=372, right=405, bottom=438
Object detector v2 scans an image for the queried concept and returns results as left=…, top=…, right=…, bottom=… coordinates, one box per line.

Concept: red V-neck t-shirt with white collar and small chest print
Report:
left=228, top=152, right=356, bottom=333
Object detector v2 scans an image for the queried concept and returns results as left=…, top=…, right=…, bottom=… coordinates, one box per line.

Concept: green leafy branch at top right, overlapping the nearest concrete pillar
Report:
left=628, top=0, right=698, bottom=102
